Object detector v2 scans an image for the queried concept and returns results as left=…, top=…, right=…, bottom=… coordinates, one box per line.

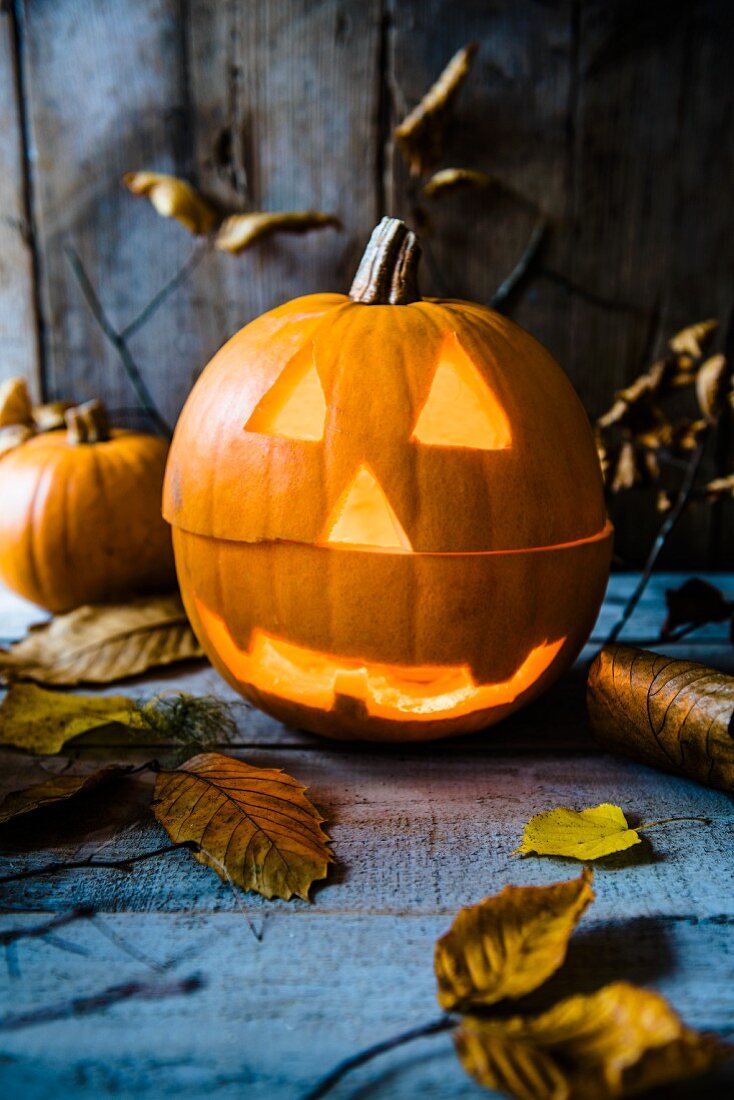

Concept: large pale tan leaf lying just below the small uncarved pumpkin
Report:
left=0, top=594, right=204, bottom=685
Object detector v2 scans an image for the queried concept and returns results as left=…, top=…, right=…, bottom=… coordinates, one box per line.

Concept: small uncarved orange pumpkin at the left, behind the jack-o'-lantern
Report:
left=0, top=402, right=175, bottom=612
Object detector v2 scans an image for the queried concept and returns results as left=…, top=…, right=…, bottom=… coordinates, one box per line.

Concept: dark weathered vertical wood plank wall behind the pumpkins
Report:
left=0, top=0, right=734, bottom=565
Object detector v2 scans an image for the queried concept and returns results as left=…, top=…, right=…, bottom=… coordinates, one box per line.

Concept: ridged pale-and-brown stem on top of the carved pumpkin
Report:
left=349, top=218, right=420, bottom=306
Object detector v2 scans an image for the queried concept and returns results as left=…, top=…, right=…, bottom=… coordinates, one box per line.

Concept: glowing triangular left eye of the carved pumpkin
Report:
left=245, top=344, right=326, bottom=441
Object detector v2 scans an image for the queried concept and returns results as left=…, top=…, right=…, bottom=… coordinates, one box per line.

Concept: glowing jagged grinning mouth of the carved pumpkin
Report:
left=195, top=597, right=566, bottom=722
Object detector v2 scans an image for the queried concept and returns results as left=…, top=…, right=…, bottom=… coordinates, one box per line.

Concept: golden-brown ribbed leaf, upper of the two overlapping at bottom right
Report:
left=434, top=868, right=594, bottom=1011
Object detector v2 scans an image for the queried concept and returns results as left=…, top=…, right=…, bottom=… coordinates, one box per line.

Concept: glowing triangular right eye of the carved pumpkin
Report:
left=410, top=336, right=512, bottom=451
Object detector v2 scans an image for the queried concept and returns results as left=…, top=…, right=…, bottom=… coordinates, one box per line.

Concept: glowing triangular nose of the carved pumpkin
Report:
left=319, top=465, right=413, bottom=552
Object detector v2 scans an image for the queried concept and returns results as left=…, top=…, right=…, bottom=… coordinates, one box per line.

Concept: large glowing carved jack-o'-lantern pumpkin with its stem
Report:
left=164, top=219, right=611, bottom=740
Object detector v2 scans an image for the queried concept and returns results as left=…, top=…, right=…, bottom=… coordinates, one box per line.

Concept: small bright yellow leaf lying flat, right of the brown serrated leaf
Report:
left=513, top=802, right=640, bottom=859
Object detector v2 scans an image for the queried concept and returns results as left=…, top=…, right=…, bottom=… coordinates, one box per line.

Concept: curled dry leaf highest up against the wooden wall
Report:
left=395, top=42, right=478, bottom=176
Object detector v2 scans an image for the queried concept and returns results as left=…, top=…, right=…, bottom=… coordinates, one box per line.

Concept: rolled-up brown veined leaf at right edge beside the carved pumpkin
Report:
left=587, top=645, right=734, bottom=791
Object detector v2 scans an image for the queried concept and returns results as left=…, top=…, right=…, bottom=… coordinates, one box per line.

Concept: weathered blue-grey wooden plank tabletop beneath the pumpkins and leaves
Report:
left=0, top=575, right=734, bottom=1100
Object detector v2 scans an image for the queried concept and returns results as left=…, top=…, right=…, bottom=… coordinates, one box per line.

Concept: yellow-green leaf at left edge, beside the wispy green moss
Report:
left=0, top=684, right=138, bottom=756
